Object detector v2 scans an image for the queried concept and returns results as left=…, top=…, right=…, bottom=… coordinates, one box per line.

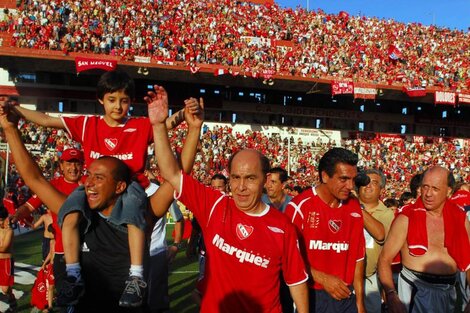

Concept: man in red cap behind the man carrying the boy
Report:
left=13, top=149, right=84, bottom=310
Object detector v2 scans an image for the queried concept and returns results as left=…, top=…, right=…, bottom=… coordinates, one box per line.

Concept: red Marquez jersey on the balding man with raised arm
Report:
left=178, top=174, right=308, bottom=313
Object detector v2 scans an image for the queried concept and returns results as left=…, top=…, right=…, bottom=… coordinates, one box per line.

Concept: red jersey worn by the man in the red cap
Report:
left=26, top=176, right=79, bottom=254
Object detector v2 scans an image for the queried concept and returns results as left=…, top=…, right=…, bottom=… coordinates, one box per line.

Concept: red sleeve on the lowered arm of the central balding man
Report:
left=282, top=224, right=308, bottom=286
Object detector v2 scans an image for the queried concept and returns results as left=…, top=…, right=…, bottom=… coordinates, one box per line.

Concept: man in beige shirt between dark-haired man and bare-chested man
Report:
left=358, top=169, right=394, bottom=312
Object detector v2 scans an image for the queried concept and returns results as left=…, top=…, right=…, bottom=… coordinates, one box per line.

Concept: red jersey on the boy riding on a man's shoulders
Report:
left=62, top=116, right=153, bottom=174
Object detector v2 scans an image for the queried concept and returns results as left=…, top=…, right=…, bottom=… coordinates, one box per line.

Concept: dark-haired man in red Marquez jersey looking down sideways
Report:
left=286, top=148, right=365, bottom=312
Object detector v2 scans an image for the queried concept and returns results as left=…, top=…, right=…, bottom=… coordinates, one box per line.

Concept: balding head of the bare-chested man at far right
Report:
left=421, top=166, right=455, bottom=211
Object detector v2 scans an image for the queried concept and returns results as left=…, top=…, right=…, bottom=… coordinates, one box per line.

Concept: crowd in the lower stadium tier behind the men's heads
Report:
left=0, top=122, right=470, bottom=205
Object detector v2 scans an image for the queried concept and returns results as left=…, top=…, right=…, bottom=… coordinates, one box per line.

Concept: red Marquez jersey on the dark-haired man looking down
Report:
left=285, top=188, right=365, bottom=289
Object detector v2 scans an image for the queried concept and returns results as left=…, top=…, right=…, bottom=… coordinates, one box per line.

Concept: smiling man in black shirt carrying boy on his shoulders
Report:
left=0, top=101, right=200, bottom=312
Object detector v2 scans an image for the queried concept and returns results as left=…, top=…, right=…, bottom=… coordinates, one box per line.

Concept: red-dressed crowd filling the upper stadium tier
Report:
left=0, top=0, right=470, bottom=90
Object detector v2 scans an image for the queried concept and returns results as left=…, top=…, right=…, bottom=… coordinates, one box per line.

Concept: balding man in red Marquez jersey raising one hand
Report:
left=148, top=86, right=308, bottom=312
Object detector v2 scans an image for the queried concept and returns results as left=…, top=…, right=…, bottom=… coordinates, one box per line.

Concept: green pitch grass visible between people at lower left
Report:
left=13, top=225, right=198, bottom=313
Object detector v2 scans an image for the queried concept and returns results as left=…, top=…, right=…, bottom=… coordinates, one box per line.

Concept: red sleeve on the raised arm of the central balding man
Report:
left=175, top=172, right=225, bottom=226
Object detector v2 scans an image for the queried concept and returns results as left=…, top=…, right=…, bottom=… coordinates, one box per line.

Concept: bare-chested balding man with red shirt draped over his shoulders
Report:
left=378, top=167, right=470, bottom=313
